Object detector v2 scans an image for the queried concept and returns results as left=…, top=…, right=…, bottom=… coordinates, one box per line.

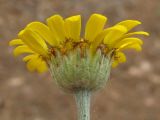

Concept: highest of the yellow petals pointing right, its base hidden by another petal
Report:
left=117, top=20, right=141, bottom=31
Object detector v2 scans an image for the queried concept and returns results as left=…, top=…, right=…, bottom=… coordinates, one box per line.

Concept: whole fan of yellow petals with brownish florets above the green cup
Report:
left=10, top=14, right=149, bottom=72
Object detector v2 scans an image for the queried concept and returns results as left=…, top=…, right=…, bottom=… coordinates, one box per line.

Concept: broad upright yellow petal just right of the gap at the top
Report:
left=85, top=14, right=107, bottom=42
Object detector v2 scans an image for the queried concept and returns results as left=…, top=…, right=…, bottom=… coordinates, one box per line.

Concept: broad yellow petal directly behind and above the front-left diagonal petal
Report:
left=27, top=22, right=58, bottom=46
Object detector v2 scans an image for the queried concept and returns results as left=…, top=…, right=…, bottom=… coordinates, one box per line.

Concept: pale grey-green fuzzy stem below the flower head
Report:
left=75, top=90, right=91, bottom=120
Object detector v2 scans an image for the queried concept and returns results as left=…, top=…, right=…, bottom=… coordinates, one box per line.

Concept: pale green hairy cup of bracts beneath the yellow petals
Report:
left=50, top=50, right=111, bottom=92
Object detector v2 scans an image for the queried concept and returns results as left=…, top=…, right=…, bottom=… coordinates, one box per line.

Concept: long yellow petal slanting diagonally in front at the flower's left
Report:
left=18, top=29, right=48, bottom=57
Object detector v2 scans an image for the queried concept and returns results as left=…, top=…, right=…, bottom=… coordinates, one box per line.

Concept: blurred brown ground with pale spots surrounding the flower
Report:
left=0, top=0, right=160, bottom=120
